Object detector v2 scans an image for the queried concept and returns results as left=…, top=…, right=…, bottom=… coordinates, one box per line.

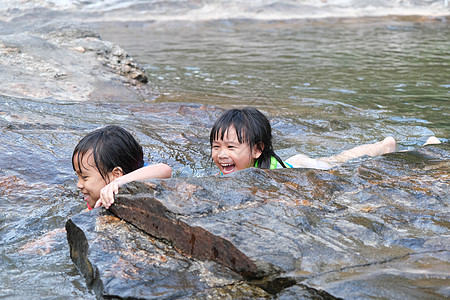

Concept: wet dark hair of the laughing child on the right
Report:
left=209, top=107, right=286, bottom=169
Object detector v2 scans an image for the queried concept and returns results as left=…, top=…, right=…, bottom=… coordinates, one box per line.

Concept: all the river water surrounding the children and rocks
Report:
left=0, top=1, right=450, bottom=299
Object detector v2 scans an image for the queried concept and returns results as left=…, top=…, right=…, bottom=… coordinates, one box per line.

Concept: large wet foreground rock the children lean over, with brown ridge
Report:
left=66, top=144, right=450, bottom=299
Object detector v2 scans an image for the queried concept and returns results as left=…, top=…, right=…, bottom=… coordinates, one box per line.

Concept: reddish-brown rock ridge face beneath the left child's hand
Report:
left=111, top=186, right=259, bottom=278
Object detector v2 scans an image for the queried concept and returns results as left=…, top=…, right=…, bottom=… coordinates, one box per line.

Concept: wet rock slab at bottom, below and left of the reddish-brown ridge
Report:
left=66, top=209, right=267, bottom=299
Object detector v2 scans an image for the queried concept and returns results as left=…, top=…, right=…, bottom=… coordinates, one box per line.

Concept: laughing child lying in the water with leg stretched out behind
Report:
left=209, top=107, right=396, bottom=174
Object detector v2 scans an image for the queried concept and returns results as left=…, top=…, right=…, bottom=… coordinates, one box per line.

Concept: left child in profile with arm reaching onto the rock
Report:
left=72, top=125, right=172, bottom=210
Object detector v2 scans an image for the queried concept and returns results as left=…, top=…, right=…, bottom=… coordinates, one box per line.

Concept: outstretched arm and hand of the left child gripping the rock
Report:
left=95, top=163, right=172, bottom=208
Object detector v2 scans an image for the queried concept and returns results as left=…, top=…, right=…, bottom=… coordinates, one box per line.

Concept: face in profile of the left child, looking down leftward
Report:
left=73, top=151, right=112, bottom=208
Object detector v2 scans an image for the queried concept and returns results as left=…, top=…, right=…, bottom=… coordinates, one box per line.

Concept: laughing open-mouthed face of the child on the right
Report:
left=211, top=126, right=262, bottom=175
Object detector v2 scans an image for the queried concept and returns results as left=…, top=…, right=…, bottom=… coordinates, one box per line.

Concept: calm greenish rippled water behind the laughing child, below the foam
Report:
left=94, top=18, right=450, bottom=150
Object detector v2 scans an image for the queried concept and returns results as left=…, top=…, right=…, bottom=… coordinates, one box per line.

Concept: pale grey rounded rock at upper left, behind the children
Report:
left=0, top=21, right=156, bottom=101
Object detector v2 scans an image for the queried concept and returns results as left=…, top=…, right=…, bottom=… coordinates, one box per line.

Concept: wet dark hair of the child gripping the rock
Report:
left=72, top=125, right=144, bottom=182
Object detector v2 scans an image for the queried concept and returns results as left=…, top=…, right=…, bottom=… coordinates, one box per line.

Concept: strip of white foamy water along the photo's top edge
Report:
left=0, top=0, right=450, bottom=21
